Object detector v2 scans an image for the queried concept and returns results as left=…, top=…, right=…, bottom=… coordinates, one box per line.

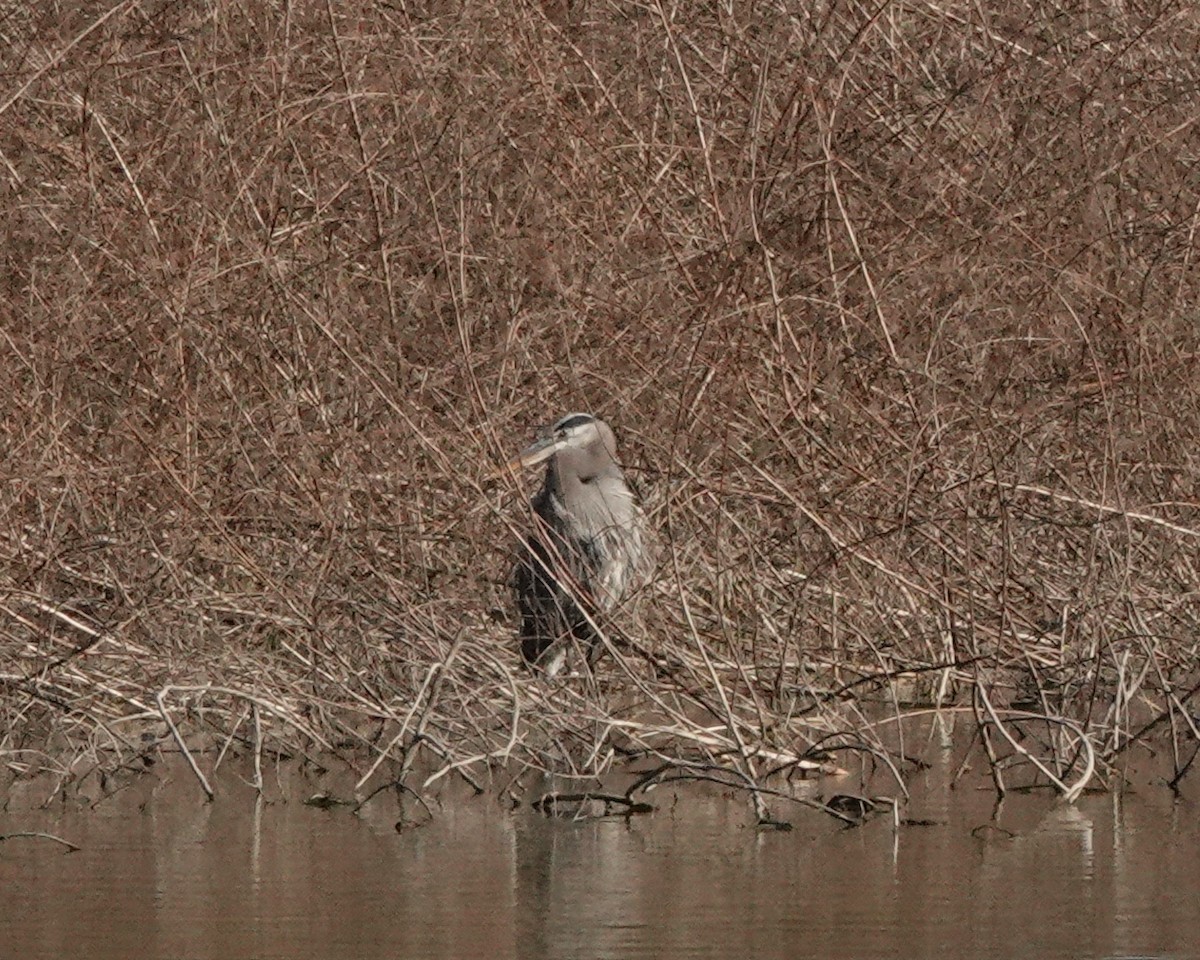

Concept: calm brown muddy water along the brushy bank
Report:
left=0, top=744, right=1200, bottom=960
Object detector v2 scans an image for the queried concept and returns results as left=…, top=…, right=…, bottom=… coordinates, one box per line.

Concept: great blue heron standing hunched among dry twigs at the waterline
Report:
left=499, top=413, right=652, bottom=676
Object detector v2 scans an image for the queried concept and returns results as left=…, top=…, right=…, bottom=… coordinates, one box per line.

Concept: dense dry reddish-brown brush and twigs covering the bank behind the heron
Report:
left=0, top=0, right=1200, bottom=816
